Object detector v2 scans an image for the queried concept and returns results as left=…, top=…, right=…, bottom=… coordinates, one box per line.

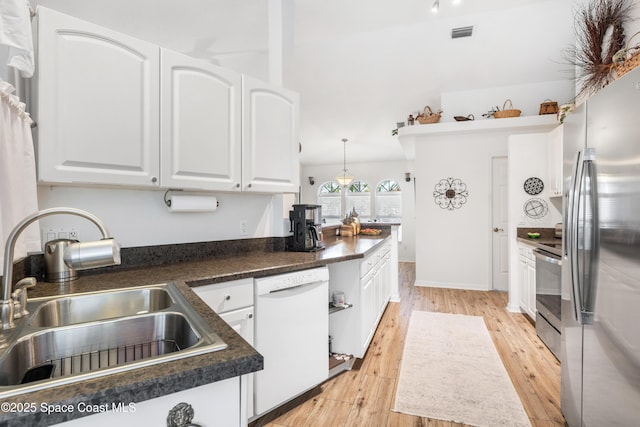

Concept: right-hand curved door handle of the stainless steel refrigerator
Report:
left=582, top=148, right=600, bottom=325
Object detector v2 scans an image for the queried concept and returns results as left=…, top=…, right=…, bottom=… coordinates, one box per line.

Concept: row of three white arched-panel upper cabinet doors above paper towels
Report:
left=34, top=7, right=300, bottom=193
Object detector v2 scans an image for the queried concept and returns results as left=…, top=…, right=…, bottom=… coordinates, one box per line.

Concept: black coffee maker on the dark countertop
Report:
left=288, top=205, right=324, bottom=252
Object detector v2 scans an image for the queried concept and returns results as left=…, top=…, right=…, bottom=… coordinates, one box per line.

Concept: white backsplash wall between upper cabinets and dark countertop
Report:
left=38, top=185, right=283, bottom=247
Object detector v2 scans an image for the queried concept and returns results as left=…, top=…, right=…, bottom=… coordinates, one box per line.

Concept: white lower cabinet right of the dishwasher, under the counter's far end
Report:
left=329, top=239, right=397, bottom=358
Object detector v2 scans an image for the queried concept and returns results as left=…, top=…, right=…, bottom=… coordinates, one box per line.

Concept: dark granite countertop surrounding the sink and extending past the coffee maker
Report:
left=0, top=230, right=390, bottom=426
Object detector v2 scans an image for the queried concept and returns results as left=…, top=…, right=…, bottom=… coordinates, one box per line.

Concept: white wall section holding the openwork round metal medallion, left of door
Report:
left=415, top=133, right=510, bottom=290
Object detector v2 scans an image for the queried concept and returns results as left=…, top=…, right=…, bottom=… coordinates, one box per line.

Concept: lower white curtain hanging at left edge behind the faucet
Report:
left=0, top=80, right=41, bottom=275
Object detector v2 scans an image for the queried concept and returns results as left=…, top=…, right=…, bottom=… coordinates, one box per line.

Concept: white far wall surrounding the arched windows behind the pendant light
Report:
left=300, top=157, right=416, bottom=262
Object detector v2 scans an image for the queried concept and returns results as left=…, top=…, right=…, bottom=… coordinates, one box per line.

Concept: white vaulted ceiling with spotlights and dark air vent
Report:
left=32, top=0, right=573, bottom=164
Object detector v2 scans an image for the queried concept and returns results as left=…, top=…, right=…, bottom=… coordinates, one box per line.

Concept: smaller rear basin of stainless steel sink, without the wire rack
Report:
left=27, top=287, right=174, bottom=327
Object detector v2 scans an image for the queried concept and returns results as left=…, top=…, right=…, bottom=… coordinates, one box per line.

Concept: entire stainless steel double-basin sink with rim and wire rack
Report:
left=0, top=283, right=227, bottom=398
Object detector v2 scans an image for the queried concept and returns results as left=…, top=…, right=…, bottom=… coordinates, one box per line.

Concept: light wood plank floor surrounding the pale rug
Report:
left=252, top=263, right=564, bottom=427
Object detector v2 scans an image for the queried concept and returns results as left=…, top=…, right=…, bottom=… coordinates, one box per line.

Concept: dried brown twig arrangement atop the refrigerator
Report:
left=564, top=0, right=633, bottom=98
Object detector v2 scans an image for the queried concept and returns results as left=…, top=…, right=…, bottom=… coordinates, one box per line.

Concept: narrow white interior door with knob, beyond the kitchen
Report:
left=491, top=156, right=509, bottom=291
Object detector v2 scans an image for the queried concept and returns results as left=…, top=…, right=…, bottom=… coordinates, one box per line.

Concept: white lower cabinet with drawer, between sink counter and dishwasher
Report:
left=192, top=278, right=255, bottom=423
